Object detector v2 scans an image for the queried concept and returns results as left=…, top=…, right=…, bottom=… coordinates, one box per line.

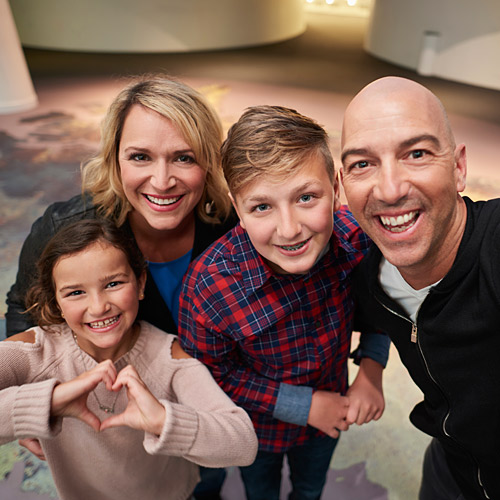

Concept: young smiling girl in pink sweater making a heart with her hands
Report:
left=0, top=220, right=257, bottom=500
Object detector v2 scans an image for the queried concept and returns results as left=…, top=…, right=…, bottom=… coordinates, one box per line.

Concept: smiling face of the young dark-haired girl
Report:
left=52, top=241, right=146, bottom=362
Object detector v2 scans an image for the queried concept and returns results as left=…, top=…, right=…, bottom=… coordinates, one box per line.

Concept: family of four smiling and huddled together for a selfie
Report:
left=0, top=75, right=500, bottom=500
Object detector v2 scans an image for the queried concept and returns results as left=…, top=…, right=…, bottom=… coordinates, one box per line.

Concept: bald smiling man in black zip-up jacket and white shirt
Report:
left=341, top=77, right=500, bottom=500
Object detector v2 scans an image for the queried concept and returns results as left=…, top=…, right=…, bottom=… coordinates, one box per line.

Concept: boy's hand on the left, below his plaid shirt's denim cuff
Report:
left=307, top=391, right=349, bottom=438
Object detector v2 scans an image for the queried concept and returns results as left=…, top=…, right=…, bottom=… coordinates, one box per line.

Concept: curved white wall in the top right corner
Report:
left=365, top=0, right=500, bottom=90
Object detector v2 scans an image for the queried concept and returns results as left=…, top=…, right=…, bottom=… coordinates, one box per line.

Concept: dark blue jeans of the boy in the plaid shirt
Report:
left=240, top=436, right=338, bottom=500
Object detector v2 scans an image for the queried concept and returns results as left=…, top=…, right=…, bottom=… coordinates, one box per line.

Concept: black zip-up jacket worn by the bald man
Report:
left=353, top=197, right=500, bottom=500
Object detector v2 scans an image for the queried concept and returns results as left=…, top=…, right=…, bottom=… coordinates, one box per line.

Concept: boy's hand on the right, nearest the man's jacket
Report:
left=347, top=358, right=385, bottom=425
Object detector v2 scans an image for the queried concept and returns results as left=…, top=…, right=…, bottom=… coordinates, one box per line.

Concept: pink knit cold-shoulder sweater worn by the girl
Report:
left=0, top=322, right=257, bottom=500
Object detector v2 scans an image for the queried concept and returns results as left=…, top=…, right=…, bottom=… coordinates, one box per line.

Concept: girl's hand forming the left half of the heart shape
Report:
left=51, top=359, right=116, bottom=431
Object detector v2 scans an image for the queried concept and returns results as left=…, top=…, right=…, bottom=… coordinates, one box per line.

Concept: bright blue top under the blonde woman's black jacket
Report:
left=148, top=249, right=192, bottom=326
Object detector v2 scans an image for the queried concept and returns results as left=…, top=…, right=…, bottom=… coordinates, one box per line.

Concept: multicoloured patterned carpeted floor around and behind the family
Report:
left=0, top=8, right=500, bottom=500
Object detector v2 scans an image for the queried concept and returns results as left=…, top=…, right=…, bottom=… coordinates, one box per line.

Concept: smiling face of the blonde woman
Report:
left=118, top=104, right=206, bottom=236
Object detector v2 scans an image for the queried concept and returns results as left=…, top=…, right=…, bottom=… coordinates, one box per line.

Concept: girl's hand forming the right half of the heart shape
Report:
left=101, top=365, right=165, bottom=436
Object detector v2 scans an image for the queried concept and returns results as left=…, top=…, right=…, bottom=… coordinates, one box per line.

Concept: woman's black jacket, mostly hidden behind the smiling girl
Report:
left=5, top=195, right=237, bottom=337
